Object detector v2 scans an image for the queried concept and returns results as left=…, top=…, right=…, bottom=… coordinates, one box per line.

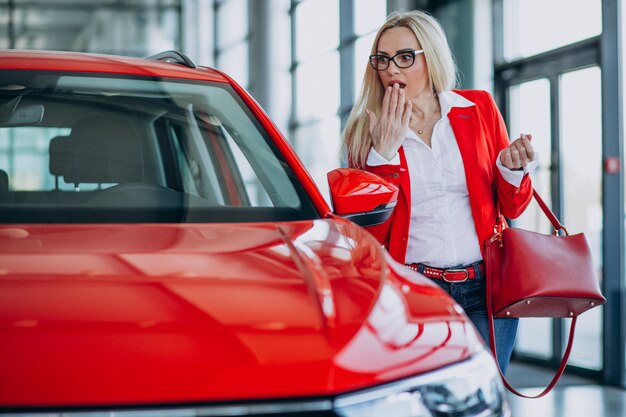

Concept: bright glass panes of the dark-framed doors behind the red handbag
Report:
left=509, top=66, right=602, bottom=370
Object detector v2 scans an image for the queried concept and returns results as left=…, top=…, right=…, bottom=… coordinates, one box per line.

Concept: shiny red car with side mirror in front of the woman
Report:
left=0, top=51, right=509, bottom=417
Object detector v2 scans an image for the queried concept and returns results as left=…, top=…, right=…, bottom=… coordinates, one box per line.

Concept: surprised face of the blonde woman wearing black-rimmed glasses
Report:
left=376, top=27, right=431, bottom=99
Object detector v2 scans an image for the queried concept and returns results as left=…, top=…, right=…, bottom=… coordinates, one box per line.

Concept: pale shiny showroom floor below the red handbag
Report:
left=508, top=362, right=626, bottom=417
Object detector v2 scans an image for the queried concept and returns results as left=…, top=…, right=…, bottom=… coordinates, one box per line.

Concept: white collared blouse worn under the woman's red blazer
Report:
left=367, top=91, right=527, bottom=268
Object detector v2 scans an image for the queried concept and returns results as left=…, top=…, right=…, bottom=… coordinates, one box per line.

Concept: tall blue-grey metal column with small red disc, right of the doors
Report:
left=601, top=0, right=626, bottom=386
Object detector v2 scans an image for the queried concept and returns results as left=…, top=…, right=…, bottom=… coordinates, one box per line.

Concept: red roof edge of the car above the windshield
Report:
left=0, top=49, right=230, bottom=83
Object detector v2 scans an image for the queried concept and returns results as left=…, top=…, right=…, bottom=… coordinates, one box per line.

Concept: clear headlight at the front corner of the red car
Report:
left=335, top=350, right=511, bottom=417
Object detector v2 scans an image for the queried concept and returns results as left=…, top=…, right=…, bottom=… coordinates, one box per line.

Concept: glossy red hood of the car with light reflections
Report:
left=0, top=219, right=478, bottom=407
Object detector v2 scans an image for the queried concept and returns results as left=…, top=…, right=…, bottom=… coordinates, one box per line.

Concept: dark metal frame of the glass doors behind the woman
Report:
left=492, top=0, right=626, bottom=387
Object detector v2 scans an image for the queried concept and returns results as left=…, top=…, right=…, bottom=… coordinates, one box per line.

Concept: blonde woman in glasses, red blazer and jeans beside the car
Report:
left=344, top=11, right=534, bottom=372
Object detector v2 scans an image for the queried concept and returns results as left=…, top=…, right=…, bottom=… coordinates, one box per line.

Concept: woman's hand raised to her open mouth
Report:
left=365, top=84, right=412, bottom=161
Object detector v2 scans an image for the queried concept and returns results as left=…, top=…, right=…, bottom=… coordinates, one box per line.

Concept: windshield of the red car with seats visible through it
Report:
left=0, top=71, right=317, bottom=223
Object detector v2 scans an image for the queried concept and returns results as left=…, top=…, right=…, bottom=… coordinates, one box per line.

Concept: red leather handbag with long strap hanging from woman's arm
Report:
left=485, top=190, right=606, bottom=398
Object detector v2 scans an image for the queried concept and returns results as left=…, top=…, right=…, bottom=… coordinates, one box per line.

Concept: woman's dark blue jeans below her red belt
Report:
left=433, top=274, right=519, bottom=374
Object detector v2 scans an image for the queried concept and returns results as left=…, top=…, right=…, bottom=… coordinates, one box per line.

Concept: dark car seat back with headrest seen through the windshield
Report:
left=50, top=113, right=143, bottom=184
